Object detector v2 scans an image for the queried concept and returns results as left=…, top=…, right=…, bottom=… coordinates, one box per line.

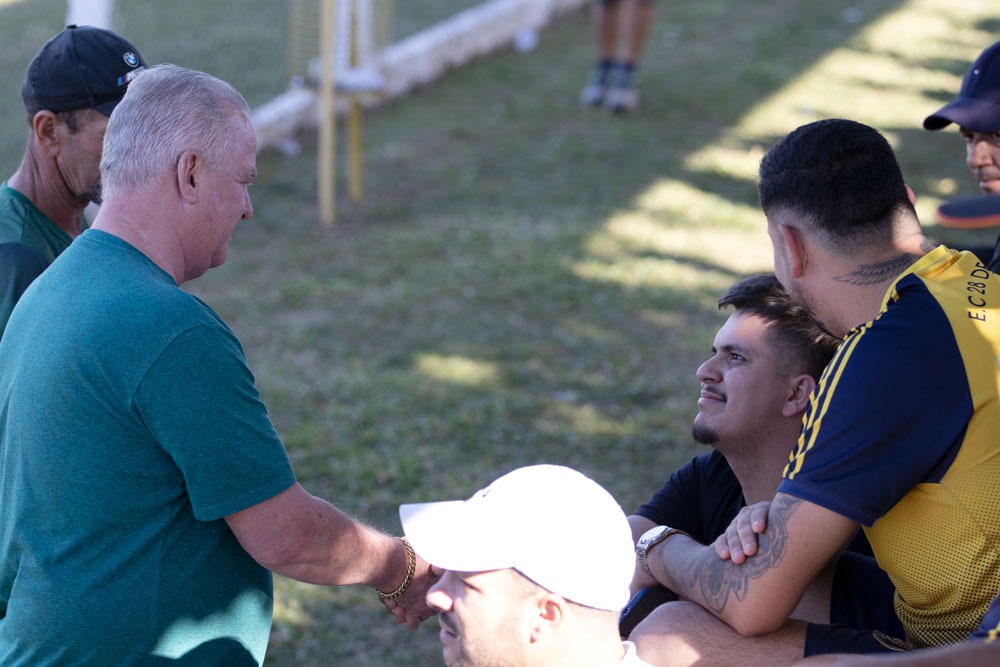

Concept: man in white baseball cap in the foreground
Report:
left=399, top=465, right=647, bottom=667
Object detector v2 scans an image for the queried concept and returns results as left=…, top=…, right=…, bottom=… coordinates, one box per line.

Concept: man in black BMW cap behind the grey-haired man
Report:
left=0, top=25, right=146, bottom=335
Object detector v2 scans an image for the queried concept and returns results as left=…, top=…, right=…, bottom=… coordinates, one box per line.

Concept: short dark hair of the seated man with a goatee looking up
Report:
left=719, top=273, right=841, bottom=382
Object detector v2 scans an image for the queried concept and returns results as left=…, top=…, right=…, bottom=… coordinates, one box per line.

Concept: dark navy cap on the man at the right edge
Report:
left=924, top=42, right=1000, bottom=133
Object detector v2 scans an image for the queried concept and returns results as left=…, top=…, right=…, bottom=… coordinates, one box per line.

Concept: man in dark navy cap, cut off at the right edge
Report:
left=924, top=42, right=1000, bottom=273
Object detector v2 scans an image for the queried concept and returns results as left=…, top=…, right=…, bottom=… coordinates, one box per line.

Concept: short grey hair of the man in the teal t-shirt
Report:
left=101, top=64, right=250, bottom=199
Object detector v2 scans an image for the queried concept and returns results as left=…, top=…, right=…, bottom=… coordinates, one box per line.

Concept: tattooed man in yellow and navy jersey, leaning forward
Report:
left=633, top=119, right=1000, bottom=665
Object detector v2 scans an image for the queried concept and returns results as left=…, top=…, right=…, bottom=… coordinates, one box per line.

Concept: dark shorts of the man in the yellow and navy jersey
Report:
left=803, top=551, right=911, bottom=657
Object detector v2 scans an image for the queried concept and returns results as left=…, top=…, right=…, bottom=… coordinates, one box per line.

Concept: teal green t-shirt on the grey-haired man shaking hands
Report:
left=0, top=230, right=295, bottom=667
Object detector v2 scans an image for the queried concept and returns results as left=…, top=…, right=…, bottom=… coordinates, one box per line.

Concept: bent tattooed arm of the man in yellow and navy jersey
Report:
left=648, top=493, right=857, bottom=636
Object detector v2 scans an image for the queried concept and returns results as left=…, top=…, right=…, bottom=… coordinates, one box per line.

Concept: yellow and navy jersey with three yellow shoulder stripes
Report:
left=779, top=246, right=1000, bottom=646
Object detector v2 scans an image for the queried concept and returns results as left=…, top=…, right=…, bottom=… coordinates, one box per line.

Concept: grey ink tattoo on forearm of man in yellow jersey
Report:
left=685, top=495, right=802, bottom=614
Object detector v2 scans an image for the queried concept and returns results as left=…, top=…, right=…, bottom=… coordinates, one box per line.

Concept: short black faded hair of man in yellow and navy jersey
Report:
left=757, top=118, right=916, bottom=253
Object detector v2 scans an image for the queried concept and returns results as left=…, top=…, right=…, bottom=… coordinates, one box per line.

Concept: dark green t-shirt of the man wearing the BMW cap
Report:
left=0, top=181, right=74, bottom=336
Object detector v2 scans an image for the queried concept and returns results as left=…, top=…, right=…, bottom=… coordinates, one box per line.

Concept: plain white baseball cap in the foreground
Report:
left=399, top=465, right=635, bottom=611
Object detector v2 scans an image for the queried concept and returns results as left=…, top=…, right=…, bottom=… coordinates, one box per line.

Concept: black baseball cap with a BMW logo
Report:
left=21, top=25, right=146, bottom=116
